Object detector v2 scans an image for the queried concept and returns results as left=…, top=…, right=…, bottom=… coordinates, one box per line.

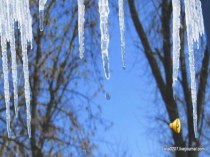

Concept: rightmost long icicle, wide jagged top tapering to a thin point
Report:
left=184, top=0, right=204, bottom=138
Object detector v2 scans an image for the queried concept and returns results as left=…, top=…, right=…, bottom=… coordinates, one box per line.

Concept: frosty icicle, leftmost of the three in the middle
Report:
left=77, top=0, right=85, bottom=59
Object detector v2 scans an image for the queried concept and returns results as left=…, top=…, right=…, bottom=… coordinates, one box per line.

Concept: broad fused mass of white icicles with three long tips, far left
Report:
left=0, top=0, right=32, bottom=137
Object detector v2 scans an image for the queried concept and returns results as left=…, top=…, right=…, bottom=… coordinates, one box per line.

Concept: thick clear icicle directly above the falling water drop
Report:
left=99, top=0, right=110, bottom=79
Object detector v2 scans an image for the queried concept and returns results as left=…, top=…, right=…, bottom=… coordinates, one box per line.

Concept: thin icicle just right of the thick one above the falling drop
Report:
left=118, top=0, right=126, bottom=69
